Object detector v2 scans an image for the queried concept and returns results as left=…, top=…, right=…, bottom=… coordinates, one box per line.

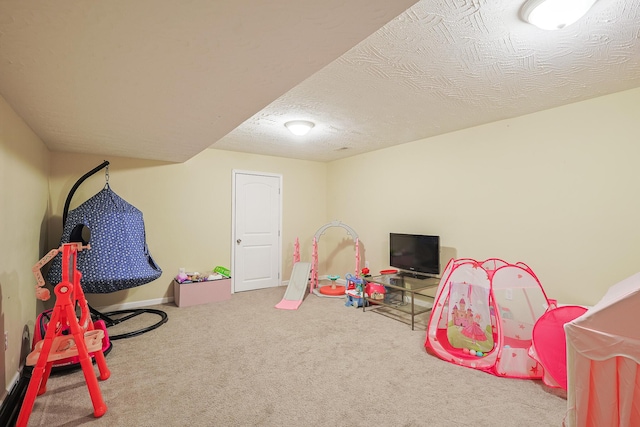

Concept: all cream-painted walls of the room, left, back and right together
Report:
left=5, top=85, right=640, bottom=400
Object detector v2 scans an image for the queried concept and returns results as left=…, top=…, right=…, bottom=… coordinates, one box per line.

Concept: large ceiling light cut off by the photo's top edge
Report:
left=520, top=0, right=597, bottom=30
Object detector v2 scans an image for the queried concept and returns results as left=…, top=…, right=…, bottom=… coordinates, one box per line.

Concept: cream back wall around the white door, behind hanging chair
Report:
left=49, top=150, right=327, bottom=307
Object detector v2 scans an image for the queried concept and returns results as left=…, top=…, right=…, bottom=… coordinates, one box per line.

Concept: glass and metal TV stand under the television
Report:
left=362, top=274, right=440, bottom=330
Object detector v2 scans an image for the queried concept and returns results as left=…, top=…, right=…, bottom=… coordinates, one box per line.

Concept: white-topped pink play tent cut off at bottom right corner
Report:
left=564, top=273, right=640, bottom=427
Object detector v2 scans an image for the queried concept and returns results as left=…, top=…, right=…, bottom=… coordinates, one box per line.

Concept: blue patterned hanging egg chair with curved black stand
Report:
left=47, top=160, right=168, bottom=340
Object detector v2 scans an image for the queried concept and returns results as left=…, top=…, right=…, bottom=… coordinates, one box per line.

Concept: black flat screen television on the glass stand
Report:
left=389, top=233, right=440, bottom=278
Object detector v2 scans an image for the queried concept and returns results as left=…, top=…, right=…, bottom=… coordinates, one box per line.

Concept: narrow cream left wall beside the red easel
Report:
left=0, top=97, right=49, bottom=399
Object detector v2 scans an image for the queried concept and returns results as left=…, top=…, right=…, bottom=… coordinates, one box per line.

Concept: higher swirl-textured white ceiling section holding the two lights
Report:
left=213, top=0, right=640, bottom=161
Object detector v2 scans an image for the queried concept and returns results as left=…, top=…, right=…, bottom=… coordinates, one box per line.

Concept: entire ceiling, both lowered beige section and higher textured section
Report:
left=0, top=0, right=640, bottom=161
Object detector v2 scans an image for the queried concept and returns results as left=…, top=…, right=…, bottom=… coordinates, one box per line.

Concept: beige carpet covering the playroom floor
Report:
left=23, top=287, right=566, bottom=427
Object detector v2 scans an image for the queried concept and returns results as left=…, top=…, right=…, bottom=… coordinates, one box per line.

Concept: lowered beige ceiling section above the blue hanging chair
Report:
left=0, top=0, right=415, bottom=162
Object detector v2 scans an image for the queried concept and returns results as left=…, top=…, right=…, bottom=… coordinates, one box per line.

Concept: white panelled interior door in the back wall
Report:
left=231, top=171, right=282, bottom=292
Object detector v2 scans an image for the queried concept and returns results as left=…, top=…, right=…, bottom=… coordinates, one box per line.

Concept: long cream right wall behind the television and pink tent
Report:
left=327, top=89, right=640, bottom=304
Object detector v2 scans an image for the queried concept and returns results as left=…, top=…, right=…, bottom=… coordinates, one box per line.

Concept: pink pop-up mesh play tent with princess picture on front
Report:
left=425, top=258, right=549, bottom=379
